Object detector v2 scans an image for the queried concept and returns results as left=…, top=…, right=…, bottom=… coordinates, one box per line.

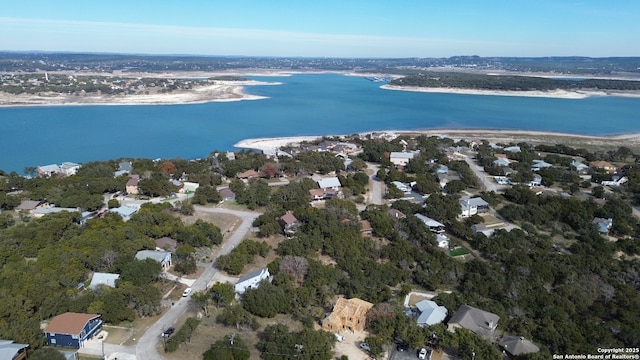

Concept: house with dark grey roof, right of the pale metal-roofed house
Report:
left=447, top=305, right=500, bottom=343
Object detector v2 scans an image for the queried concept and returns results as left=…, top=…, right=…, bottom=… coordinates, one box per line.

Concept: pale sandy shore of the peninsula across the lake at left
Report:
left=0, top=80, right=281, bottom=107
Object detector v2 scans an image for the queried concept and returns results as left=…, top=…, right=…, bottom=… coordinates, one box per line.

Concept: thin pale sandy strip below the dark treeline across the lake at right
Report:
left=380, top=85, right=640, bottom=99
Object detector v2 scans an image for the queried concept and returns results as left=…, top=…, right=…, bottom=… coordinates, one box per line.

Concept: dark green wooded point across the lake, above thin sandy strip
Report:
left=390, top=72, right=640, bottom=91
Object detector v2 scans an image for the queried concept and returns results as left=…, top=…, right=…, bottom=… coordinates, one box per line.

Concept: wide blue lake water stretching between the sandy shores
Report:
left=0, top=74, right=640, bottom=173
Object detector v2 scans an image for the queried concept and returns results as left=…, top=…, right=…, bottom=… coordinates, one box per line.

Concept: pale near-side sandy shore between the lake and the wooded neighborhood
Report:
left=234, top=129, right=640, bottom=151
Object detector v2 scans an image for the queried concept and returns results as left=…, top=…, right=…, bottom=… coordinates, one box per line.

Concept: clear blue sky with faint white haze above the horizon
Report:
left=0, top=0, right=640, bottom=57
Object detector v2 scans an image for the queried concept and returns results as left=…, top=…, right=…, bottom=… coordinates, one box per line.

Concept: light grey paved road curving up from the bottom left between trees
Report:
left=136, top=206, right=260, bottom=360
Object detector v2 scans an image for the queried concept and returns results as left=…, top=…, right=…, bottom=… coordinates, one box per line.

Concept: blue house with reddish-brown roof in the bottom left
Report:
left=44, top=312, right=102, bottom=348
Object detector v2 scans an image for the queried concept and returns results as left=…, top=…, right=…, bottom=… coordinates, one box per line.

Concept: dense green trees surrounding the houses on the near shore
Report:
left=0, top=136, right=640, bottom=360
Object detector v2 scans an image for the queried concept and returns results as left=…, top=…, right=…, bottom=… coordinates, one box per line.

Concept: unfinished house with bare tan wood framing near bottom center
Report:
left=322, top=297, right=373, bottom=333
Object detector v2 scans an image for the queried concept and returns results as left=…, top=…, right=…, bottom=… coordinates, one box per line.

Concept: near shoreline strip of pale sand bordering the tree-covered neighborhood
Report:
left=233, top=129, right=640, bottom=151
